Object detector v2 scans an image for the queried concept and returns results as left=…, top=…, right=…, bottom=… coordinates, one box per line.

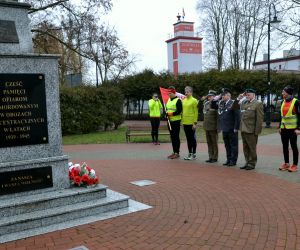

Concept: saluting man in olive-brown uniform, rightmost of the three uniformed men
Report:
left=238, top=89, right=264, bottom=170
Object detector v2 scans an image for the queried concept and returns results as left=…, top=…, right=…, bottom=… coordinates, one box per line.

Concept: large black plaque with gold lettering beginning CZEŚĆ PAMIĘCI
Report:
left=0, top=74, right=48, bottom=148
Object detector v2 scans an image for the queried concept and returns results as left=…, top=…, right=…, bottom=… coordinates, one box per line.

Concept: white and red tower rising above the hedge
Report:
left=166, top=14, right=203, bottom=76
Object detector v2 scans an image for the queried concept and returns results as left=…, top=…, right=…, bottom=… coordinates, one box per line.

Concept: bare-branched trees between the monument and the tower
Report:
left=23, top=0, right=135, bottom=83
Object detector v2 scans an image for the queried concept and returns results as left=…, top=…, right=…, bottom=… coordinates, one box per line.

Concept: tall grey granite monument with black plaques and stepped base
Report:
left=0, top=0, right=148, bottom=243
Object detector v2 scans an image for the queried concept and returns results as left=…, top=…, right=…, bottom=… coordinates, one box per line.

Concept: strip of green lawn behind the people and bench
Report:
left=63, top=122, right=277, bottom=145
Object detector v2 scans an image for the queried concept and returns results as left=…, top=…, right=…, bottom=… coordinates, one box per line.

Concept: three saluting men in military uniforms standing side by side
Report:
left=203, top=89, right=264, bottom=170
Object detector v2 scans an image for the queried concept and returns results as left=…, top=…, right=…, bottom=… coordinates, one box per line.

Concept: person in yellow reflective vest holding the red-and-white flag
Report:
left=166, top=86, right=182, bottom=159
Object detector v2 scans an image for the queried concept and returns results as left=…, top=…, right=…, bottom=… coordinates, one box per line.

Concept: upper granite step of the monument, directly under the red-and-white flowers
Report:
left=0, top=184, right=107, bottom=217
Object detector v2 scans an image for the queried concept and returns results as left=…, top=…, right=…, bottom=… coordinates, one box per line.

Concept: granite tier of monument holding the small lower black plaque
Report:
left=0, top=155, right=70, bottom=199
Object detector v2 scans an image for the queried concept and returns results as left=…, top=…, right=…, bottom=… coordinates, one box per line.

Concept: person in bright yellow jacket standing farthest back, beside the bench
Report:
left=148, top=93, right=163, bottom=145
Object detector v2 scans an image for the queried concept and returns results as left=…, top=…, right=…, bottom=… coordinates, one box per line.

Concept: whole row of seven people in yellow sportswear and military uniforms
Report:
left=149, top=86, right=300, bottom=172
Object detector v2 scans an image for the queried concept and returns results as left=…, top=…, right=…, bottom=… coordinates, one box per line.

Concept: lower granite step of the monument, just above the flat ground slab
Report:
left=0, top=189, right=129, bottom=235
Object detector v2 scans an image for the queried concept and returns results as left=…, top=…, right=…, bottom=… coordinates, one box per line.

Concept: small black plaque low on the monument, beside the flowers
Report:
left=0, top=167, right=53, bottom=195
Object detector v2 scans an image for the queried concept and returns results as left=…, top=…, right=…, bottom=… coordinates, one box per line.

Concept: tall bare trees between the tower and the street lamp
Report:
left=197, top=0, right=284, bottom=70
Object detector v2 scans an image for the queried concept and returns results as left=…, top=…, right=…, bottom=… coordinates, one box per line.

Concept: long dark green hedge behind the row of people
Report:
left=119, top=69, right=300, bottom=100
